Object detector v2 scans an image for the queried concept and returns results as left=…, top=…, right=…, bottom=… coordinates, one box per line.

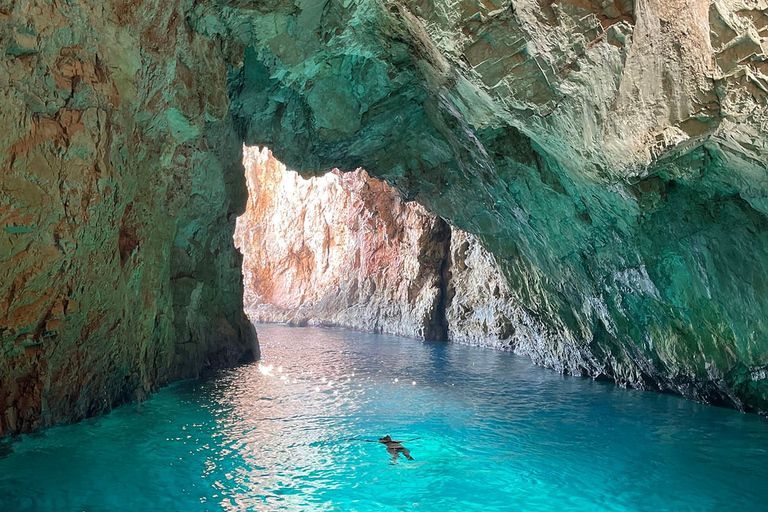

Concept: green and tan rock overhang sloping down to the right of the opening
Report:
left=219, top=0, right=768, bottom=411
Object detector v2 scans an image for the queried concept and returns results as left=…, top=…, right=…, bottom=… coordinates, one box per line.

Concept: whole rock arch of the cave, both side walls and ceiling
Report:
left=0, top=0, right=768, bottom=432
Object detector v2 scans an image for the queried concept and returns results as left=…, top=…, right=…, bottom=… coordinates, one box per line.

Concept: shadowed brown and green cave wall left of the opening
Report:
left=0, top=1, right=258, bottom=435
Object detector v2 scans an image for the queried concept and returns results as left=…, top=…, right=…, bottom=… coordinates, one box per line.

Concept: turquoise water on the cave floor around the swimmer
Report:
left=0, top=326, right=768, bottom=512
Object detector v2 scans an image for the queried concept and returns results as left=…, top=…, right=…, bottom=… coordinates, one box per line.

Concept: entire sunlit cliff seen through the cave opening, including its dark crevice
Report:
left=235, top=147, right=584, bottom=371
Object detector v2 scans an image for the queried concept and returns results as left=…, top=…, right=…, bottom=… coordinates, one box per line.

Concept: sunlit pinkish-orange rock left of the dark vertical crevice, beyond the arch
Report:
left=235, top=147, right=451, bottom=340
